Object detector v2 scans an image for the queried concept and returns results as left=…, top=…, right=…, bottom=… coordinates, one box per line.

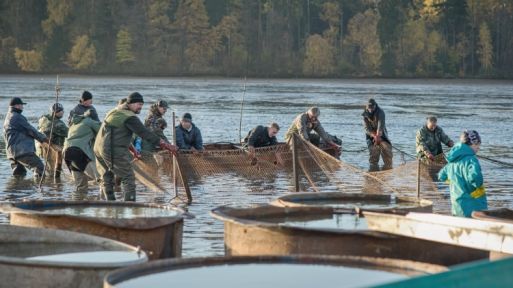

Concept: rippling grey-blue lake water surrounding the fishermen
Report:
left=0, top=76, right=513, bottom=257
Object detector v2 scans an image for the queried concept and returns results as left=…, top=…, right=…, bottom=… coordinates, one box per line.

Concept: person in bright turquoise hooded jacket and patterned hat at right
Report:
left=438, top=130, right=488, bottom=217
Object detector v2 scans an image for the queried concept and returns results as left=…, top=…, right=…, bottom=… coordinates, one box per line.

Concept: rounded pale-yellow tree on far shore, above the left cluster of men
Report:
left=67, top=35, right=96, bottom=71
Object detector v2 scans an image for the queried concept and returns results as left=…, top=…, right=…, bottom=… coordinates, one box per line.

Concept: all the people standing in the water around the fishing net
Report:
left=4, top=95, right=487, bottom=217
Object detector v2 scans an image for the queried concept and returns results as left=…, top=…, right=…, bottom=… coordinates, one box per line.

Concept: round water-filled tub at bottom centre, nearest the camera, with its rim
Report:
left=104, top=255, right=446, bottom=288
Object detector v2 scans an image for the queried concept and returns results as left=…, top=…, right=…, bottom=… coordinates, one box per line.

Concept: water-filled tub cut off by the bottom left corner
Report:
left=0, top=225, right=148, bottom=288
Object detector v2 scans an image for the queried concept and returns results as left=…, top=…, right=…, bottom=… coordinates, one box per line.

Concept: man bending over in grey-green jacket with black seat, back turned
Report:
left=63, top=110, right=101, bottom=197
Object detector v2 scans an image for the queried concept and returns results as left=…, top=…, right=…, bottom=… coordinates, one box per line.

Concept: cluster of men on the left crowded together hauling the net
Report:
left=4, top=91, right=203, bottom=201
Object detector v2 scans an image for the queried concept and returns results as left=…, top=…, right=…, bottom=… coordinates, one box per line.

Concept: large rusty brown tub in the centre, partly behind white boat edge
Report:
left=211, top=206, right=488, bottom=266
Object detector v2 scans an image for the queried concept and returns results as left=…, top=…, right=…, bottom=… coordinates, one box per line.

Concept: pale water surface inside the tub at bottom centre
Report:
left=115, top=264, right=407, bottom=288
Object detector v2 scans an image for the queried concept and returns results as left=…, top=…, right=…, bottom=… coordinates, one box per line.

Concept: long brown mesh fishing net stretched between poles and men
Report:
left=136, top=135, right=444, bottom=202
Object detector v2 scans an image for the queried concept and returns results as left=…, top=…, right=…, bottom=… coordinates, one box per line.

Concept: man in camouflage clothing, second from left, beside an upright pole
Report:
left=37, top=103, right=68, bottom=178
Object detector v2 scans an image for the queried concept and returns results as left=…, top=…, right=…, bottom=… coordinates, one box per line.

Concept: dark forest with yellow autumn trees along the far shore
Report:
left=0, top=0, right=513, bottom=79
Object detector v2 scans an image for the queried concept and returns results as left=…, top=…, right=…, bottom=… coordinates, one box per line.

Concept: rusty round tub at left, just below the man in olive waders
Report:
left=0, top=200, right=185, bottom=259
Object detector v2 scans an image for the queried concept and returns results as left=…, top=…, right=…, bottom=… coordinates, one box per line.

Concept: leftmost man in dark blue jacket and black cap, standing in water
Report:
left=4, top=97, right=49, bottom=180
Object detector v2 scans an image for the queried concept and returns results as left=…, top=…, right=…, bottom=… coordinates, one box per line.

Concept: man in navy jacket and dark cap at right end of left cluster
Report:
left=175, top=113, right=203, bottom=151
